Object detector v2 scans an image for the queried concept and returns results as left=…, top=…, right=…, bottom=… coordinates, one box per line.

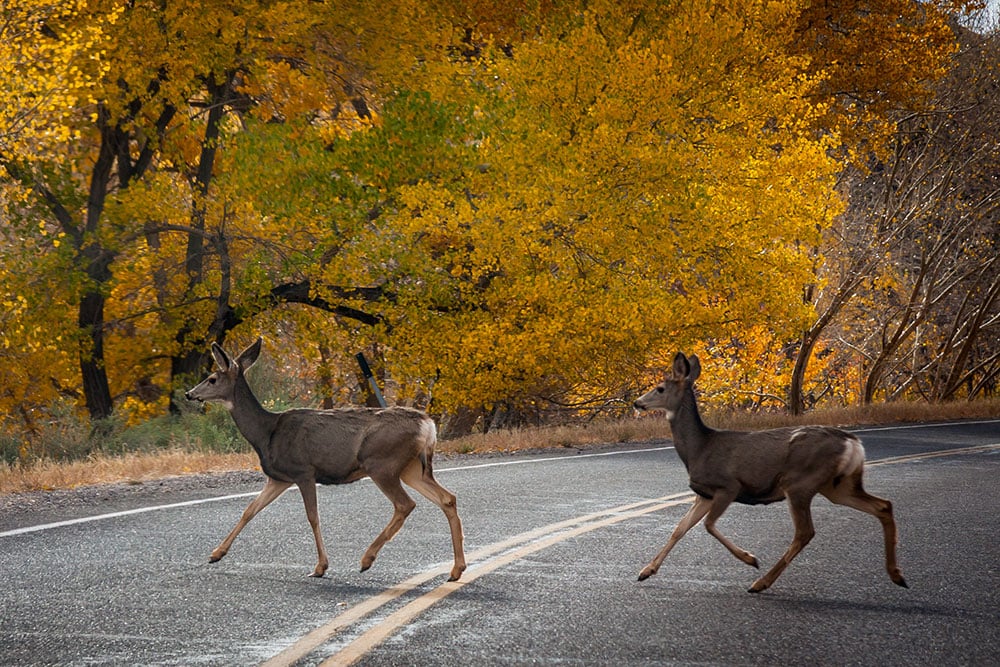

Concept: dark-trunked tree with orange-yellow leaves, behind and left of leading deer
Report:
left=3, top=0, right=454, bottom=426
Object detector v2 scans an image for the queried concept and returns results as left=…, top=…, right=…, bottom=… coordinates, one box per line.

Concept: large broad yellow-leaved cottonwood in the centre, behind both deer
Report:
left=99, top=3, right=837, bottom=426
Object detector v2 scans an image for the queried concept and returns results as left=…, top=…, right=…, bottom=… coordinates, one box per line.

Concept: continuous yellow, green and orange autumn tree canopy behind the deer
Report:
left=0, top=0, right=984, bottom=444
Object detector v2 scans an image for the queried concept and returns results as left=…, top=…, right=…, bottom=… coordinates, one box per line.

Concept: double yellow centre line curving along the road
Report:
left=264, top=443, right=1000, bottom=667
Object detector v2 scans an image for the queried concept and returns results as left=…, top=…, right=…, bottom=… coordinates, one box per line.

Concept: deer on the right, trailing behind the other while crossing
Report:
left=634, top=352, right=907, bottom=593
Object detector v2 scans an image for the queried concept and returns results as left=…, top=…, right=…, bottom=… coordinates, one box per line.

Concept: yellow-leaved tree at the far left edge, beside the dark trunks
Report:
left=0, top=0, right=116, bottom=422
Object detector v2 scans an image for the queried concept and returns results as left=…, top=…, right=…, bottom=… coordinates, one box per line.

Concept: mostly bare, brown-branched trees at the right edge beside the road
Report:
left=792, top=26, right=1000, bottom=410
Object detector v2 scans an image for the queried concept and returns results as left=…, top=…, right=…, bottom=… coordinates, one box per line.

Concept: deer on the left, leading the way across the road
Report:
left=185, top=338, right=466, bottom=581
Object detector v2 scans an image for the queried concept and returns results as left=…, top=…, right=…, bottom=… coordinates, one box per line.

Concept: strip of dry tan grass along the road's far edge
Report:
left=0, top=399, right=1000, bottom=494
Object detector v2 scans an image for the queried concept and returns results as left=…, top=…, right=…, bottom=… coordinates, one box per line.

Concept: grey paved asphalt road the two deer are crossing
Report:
left=0, top=421, right=1000, bottom=666
